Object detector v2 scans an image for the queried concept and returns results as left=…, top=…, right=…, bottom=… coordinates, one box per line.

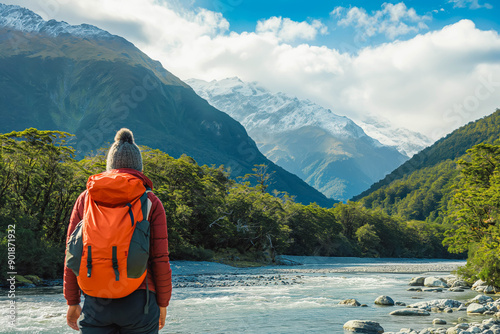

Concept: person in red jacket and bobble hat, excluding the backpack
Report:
left=63, top=128, right=172, bottom=334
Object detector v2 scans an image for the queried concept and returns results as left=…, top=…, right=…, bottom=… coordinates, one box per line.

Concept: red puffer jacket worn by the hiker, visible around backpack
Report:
left=63, top=168, right=172, bottom=307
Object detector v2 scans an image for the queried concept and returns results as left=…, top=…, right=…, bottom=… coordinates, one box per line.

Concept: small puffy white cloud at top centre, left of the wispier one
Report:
left=255, top=16, right=328, bottom=42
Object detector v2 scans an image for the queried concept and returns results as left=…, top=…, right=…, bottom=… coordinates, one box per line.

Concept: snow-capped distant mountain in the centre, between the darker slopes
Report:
left=186, top=78, right=408, bottom=200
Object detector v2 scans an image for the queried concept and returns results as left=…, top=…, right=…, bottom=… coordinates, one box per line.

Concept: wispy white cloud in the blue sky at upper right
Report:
left=331, top=2, right=430, bottom=39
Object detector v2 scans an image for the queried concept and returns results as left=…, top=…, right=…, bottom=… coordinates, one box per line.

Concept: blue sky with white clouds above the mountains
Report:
left=0, top=0, right=500, bottom=140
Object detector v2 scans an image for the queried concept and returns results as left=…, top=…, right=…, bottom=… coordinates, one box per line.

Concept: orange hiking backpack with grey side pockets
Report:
left=66, top=171, right=151, bottom=298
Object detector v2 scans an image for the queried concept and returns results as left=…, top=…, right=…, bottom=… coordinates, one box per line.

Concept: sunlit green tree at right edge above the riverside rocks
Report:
left=443, top=144, right=500, bottom=286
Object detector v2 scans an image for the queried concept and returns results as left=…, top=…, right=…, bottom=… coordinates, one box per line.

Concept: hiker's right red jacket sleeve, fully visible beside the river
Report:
left=149, top=193, right=172, bottom=307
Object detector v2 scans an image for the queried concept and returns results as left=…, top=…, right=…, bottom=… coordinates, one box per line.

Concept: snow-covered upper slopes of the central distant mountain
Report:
left=186, top=78, right=374, bottom=141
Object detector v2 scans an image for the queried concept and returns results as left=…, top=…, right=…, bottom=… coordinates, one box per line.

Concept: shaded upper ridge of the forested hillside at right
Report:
left=352, top=110, right=500, bottom=201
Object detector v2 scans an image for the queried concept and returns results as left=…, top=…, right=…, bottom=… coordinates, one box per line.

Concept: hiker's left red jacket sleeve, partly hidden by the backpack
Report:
left=63, top=191, right=87, bottom=305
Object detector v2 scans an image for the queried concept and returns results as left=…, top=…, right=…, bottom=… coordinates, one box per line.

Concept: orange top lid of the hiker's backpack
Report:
left=87, top=168, right=153, bottom=206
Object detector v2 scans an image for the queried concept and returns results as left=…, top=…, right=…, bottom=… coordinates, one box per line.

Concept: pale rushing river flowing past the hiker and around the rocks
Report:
left=0, top=262, right=479, bottom=333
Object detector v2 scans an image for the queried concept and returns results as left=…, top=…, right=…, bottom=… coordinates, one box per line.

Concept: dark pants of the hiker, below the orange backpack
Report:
left=78, top=289, right=160, bottom=334
